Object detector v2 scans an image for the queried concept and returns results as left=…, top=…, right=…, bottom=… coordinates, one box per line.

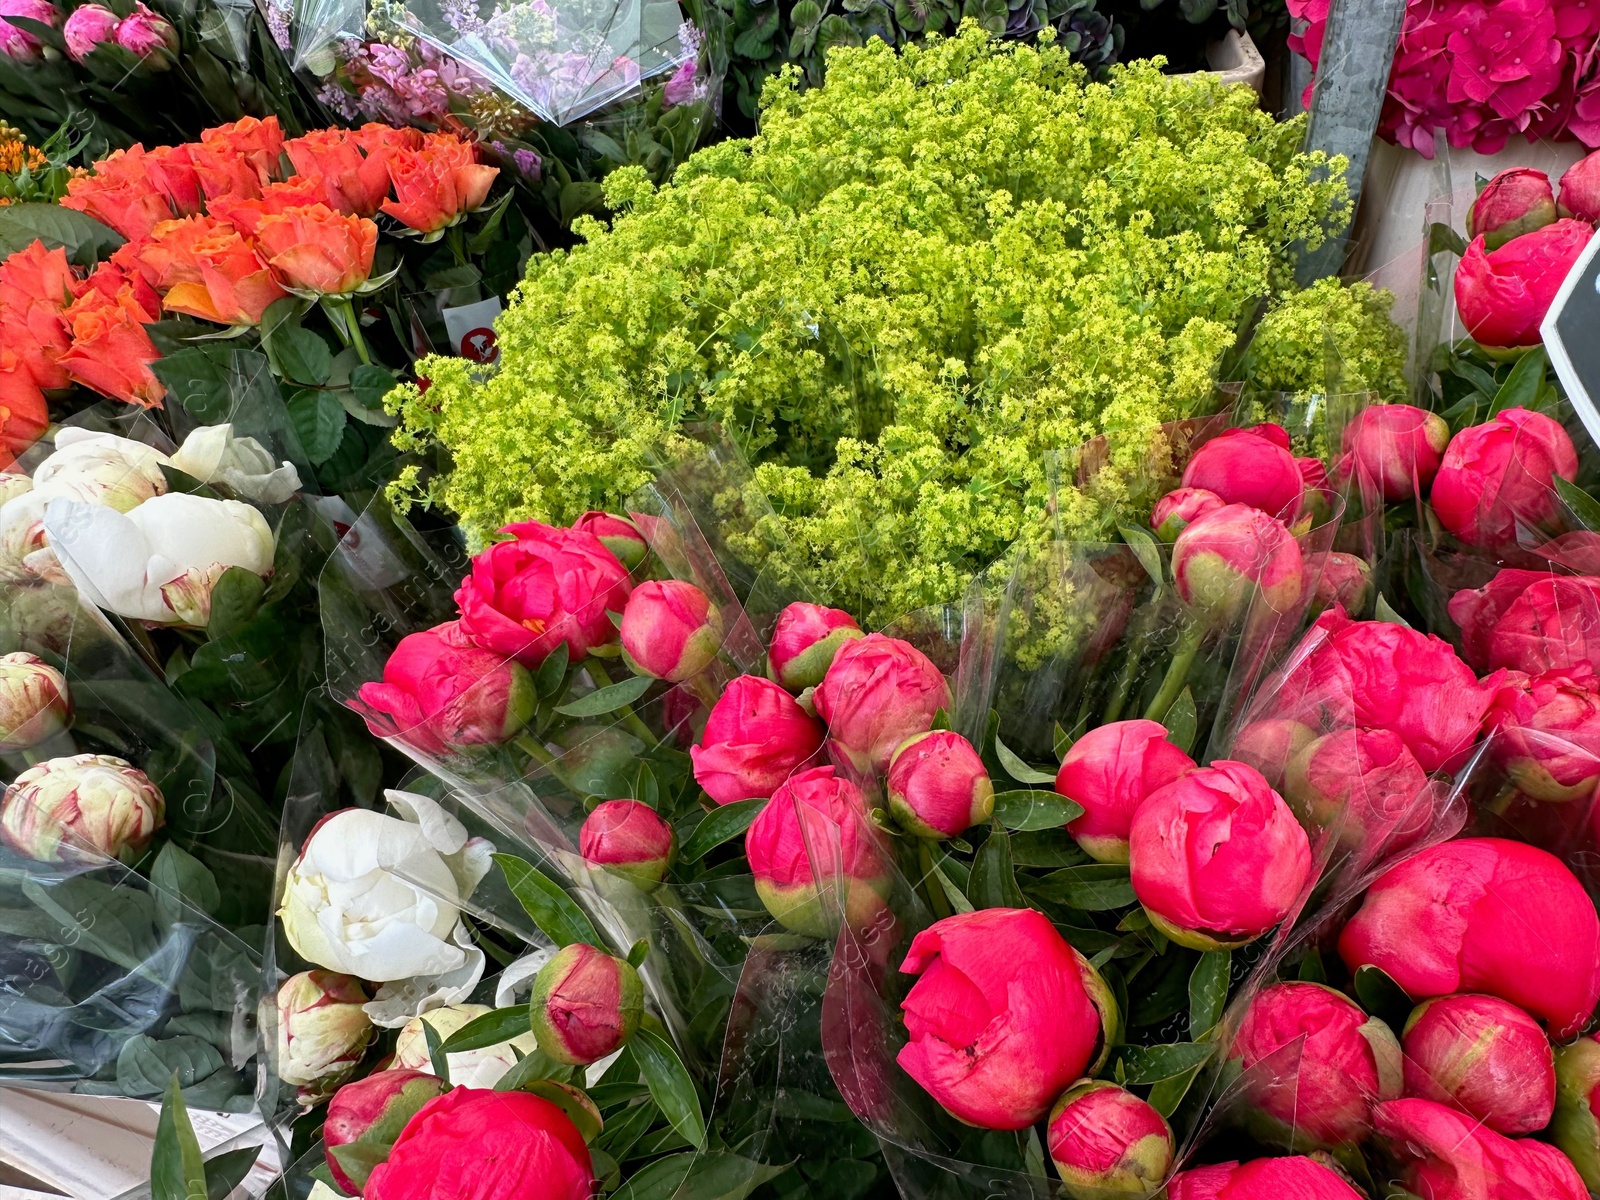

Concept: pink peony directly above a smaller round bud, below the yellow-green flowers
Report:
left=813, top=634, right=950, bottom=774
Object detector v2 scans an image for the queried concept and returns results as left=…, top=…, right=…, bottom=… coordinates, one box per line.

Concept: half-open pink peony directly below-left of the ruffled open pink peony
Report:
left=358, top=621, right=539, bottom=755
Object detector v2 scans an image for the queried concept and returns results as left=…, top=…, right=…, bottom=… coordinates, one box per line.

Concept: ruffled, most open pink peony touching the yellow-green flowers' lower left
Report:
left=456, top=522, right=629, bottom=667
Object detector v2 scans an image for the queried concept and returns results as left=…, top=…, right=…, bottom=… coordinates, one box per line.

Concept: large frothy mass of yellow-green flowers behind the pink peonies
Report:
left=390, top=26, right=1390, bottom=622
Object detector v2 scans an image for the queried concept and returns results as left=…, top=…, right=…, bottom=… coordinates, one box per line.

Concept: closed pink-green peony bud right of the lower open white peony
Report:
left=528, top=942, right=645, bottom=1066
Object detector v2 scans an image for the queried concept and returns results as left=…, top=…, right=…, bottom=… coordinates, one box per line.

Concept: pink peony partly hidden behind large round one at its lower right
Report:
left=1056, top=720, right=1195, bottom=862
